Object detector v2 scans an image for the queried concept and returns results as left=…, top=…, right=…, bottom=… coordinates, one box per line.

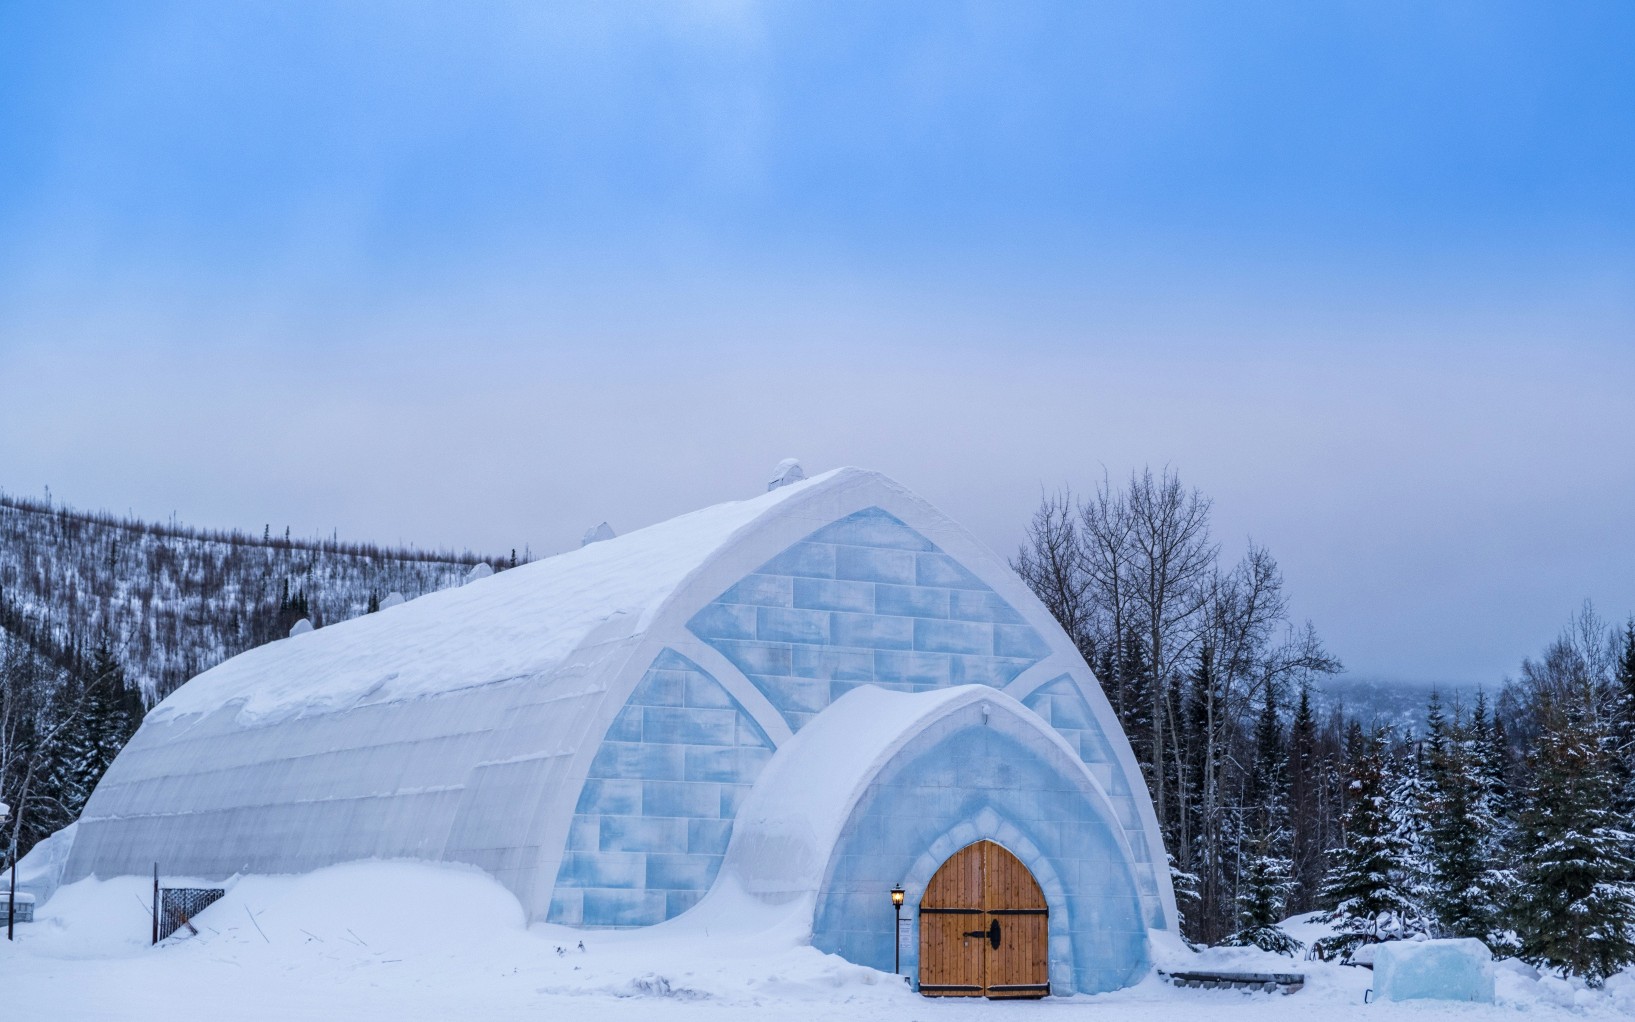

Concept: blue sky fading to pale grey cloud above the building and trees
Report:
left=0, top=2, right=1635, bottom=680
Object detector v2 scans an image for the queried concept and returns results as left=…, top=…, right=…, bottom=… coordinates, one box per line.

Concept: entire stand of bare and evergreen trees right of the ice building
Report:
left=1012, top=471, right=1635, bottom=984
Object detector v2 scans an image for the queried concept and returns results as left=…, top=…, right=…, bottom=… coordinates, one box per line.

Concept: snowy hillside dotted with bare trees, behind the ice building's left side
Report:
left=0, top=494, right=512, bottom=700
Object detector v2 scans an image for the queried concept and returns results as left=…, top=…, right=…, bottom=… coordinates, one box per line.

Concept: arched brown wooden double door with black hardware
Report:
left=921, top=840, right=1050, bottom=997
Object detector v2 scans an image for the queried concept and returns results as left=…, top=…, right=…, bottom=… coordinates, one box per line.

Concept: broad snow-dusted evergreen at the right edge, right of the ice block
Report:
left=1511, top=687, right=1635, bottom=986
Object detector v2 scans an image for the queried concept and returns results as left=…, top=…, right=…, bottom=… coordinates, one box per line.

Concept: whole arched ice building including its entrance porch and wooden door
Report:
left=62, top=469, right=1176, bottom=996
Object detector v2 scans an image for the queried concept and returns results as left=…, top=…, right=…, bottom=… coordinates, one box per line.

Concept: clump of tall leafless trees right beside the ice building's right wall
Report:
left=1014, top=471, right=1339, bottom=939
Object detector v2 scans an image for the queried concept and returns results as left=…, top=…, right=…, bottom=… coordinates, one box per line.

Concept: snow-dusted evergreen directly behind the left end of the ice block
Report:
left=1323, top=728, right=1422, bottom=958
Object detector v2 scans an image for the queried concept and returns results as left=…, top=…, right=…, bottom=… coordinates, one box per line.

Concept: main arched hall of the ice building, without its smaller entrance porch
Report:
left=64, top=469, right=1174, bottom=926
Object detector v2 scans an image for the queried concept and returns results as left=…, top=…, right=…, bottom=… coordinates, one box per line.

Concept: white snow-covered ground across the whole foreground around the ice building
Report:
left=0, top=862, right=1635, bottom=1022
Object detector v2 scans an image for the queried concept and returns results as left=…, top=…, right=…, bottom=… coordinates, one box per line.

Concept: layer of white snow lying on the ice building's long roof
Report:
left=149, top=468, right=863, bottom=721
